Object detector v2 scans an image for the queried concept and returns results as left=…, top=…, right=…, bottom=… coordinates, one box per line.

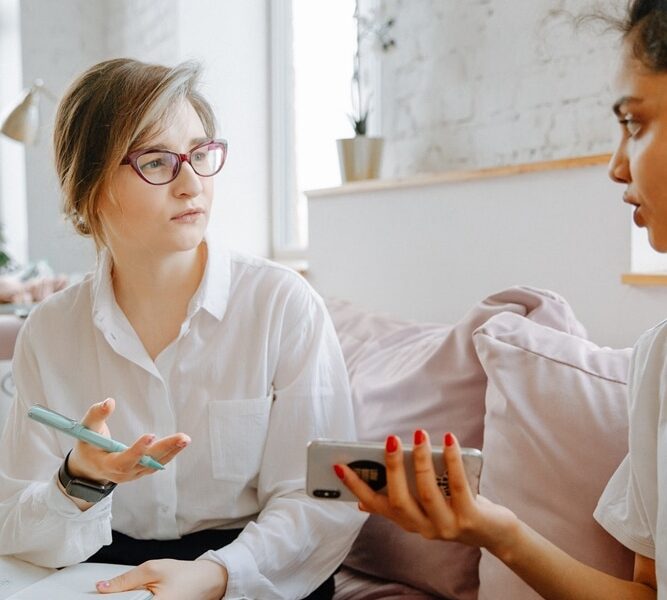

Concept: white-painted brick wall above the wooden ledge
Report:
left=371, top=0, right=618, bottom=177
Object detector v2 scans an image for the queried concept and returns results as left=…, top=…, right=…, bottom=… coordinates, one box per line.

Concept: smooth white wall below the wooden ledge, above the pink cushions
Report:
left=308, top=166, right=667, bottom=347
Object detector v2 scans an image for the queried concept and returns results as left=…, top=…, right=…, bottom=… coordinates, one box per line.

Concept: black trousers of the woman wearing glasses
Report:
left=86, top=529, right=335, bottom=600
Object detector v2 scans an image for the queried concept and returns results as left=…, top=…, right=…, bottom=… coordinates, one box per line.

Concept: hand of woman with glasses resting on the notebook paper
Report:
left=97, top=558, right=227, bottom=600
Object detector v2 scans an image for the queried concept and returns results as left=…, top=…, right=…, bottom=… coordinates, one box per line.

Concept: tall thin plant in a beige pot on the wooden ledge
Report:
left=336, top=1, right=396, bottom=182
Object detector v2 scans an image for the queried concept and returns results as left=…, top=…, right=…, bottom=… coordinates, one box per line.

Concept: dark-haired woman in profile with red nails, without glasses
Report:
left=342, top=0, right=667, bottom=600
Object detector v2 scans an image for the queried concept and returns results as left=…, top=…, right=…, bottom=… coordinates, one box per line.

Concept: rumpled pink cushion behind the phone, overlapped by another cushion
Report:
left=327, top=287, right=585, bottom=600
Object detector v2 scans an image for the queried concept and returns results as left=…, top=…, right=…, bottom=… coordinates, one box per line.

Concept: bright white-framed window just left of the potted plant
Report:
left=271, top=0, right=356, bottom=259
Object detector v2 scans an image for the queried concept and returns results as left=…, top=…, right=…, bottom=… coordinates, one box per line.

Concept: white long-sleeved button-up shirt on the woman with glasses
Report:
left=0, top=243, right=363, bottom=600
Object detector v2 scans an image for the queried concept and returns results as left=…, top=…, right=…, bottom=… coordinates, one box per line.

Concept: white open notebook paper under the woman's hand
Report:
left=0, top=563, right=153, bottom=600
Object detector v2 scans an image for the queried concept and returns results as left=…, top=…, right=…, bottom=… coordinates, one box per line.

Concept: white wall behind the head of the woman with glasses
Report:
left=15, top=0, right=269, bottom=272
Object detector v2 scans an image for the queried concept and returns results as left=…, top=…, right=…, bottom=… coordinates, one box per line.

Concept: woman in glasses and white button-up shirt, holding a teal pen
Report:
left=0, top=59, right=363, bottom=600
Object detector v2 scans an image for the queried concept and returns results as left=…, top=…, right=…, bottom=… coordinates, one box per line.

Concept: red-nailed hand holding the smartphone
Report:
left=335, top=430, right=519, bottom=555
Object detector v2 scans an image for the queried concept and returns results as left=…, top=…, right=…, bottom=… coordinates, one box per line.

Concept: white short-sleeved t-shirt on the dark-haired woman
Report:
left=594, top=321, right=667, bottom=599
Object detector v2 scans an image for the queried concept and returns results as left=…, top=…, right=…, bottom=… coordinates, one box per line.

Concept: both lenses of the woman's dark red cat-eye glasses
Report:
left=137, top=142, right=224, bottom=184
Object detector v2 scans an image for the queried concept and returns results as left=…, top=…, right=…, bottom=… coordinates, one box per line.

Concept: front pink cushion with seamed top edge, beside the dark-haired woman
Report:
left=474, top=313, right=633, bottom=600
